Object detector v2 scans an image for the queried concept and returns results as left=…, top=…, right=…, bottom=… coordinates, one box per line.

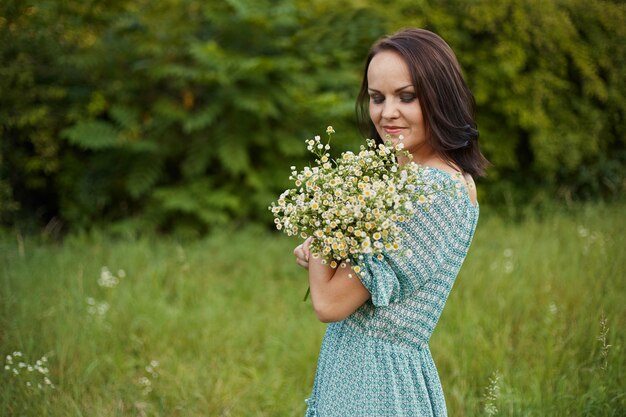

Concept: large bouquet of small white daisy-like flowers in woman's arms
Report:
left=269, top=126, right=458, bottom=273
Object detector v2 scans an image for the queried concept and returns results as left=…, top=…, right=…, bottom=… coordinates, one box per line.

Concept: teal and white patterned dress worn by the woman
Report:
left=306, top=168, right=479, bottom=417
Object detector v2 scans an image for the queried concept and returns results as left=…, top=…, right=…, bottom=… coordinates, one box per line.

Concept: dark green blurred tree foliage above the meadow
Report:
left=0, top=0, right=626, bottom=233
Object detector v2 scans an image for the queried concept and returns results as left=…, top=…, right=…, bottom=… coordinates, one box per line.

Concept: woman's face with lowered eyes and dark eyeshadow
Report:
left=367, top=51, right=431, bottom=162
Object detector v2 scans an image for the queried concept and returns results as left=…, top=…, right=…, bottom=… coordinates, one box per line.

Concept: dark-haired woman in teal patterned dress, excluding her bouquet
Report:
left=294, top=29, right=488, bottom=417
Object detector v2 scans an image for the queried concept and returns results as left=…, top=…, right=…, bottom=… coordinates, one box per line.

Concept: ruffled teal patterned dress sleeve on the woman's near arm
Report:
left=353, top=190, right=458, bottom=307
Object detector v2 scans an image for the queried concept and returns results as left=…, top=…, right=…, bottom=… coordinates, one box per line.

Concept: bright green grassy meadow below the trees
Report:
left=0, top=205, right=626, bottom=417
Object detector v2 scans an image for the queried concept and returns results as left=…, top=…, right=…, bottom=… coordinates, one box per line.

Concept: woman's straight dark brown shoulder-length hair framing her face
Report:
left=356, top=29, right=489, bottom=176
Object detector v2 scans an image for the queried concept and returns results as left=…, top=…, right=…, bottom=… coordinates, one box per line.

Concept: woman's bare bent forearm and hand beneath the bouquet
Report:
left=294, top=238, right=371, bottom=323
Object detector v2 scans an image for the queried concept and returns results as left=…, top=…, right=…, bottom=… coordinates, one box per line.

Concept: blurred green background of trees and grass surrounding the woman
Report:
left=0, top=0, right=626, bottom=417
